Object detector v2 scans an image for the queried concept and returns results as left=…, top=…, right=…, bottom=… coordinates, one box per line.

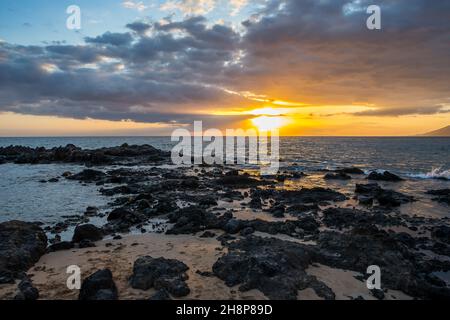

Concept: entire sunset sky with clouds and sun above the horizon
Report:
left=0, top=0, right=450, bottom=136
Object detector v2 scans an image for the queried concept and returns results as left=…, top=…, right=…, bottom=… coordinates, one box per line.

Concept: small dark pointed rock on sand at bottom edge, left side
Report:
left=78, top=269, right=118, bottom=300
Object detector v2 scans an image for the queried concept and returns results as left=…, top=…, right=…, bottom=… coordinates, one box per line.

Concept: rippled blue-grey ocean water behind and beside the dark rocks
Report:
left=0, top=137, right=450, bottom=234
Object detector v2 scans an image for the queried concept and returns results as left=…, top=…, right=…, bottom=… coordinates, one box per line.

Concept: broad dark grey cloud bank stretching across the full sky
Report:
left=0, top=0, right=450, bottom=122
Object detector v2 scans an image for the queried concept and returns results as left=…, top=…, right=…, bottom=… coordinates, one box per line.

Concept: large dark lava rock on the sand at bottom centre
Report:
left=212, top=236, right=335, bottom=300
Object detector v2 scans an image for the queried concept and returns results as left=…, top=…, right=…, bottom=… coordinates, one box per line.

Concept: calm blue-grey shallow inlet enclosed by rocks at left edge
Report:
left=0, top=163, right=111, bottom=223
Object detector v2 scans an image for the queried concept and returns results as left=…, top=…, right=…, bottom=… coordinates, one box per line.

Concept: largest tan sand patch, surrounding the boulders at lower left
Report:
left=0, top=231, right=266, bottom=300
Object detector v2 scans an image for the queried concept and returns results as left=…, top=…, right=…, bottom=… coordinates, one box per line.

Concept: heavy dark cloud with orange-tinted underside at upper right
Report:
left=235, top=0, right=450, bottom=107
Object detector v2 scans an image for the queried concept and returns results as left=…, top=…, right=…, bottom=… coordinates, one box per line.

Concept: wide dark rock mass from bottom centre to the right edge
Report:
left=212, top=224, right=450, bottom=299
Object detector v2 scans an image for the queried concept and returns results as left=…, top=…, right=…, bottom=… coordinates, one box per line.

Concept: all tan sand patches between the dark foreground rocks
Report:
left=0, top=230, right=411, bottom=300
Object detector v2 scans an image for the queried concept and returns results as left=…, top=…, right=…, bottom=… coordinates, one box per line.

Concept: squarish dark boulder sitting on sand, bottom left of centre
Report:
left=130, top=256, right=190, bottom=297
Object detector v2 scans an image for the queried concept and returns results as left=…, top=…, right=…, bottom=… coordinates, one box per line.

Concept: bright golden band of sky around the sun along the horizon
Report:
left=0, top=97, right=450, bottom=136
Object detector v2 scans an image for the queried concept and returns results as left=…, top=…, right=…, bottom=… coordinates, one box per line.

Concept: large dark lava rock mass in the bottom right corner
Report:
left=310, top=224, right=450, bottom=299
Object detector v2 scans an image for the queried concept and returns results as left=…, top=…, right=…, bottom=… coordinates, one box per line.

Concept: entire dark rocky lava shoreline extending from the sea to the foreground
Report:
left=0, top=145, right=450, bottom=300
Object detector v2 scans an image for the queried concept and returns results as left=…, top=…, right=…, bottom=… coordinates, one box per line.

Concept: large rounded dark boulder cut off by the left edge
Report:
left=0, top=221, right=47, bottom=283
